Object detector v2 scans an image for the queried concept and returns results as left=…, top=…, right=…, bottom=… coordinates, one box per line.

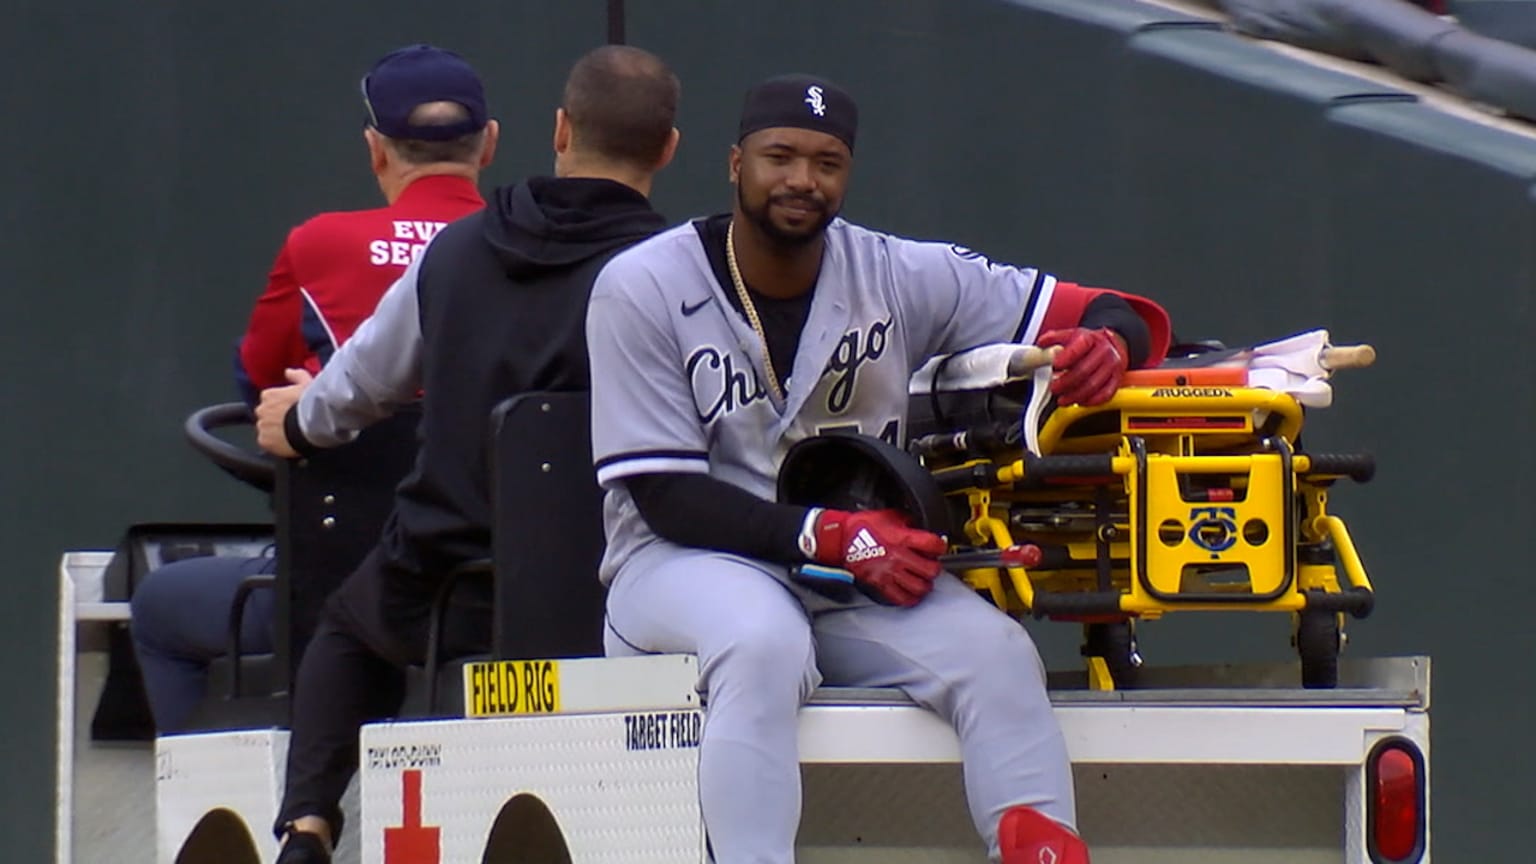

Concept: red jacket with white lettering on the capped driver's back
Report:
left=235, top=174, right=485, bottom=406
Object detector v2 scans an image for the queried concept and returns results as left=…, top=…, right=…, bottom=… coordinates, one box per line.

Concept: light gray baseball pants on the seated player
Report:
left=605, top=543, right=1077, bottom=864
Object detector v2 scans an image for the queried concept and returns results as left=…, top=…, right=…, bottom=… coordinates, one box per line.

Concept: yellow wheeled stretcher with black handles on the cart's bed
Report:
left=909, top=335, right=1373, bottom=689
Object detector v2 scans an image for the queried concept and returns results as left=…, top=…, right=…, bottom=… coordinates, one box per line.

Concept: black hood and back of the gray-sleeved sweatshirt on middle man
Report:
left=382, top=177, right=665, bottom=578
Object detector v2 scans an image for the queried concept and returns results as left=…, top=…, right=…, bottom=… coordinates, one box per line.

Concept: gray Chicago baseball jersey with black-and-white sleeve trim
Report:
left=587, top=218, right=1055, bottom=581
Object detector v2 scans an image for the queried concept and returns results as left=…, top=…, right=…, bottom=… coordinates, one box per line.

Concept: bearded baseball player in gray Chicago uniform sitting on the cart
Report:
left=587, top=75, right=1169, bottom=864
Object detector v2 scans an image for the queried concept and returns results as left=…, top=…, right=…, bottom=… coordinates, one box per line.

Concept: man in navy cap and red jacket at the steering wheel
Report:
left=132, top=45, right=498, bottom=733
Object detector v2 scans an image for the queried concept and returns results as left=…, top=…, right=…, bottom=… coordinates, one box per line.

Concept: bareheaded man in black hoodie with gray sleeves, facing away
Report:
left=257, top=46, right=679, bottom=864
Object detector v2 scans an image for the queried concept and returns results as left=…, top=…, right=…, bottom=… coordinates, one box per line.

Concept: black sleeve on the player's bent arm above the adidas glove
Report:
left=624, top=474, right=806, bottom=564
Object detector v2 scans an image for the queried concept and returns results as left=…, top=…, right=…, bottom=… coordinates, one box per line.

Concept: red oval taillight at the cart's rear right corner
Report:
left=1366, top=738, right=1424, bottom=864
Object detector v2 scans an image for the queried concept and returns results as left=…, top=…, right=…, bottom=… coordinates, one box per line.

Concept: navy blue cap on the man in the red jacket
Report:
left=362, top=45, right=487, bottom=141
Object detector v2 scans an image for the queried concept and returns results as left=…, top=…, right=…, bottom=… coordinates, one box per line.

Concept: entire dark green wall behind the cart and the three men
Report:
left=0, top=0, right=1536, bottom=861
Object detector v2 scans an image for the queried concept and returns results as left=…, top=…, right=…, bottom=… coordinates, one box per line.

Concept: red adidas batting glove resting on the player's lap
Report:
left=816, top=510, right=948, bottom=606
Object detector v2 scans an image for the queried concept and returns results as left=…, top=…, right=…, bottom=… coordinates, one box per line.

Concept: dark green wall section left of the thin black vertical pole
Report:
left=0, top=0, right=607, bottom=862
